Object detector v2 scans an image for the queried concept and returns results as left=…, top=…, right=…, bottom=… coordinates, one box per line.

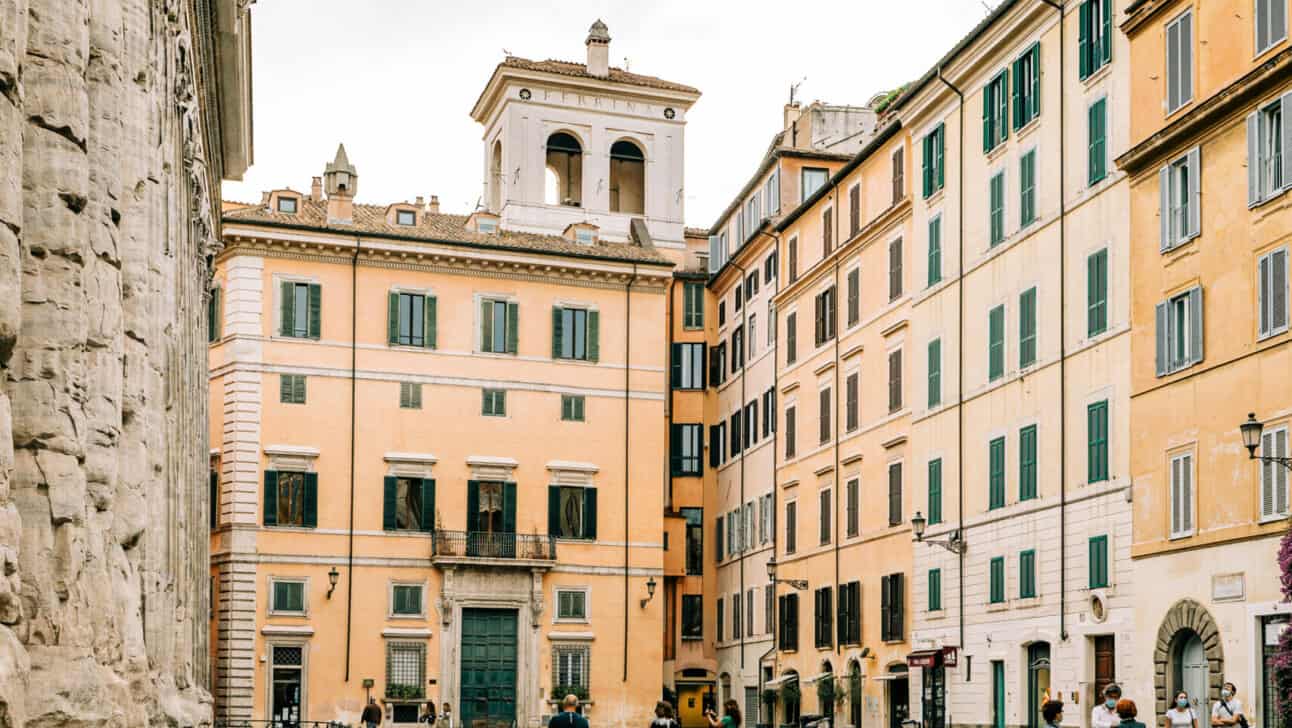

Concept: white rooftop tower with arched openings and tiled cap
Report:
left=472, top=19, right=700, bottom=247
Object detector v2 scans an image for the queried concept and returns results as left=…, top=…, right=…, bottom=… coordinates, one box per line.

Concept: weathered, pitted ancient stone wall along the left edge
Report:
left=0, top=0, right=223, bottom=728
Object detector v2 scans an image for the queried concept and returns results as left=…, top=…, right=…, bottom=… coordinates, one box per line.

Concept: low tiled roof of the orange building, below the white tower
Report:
left=224, top=198, right=672, bottom=265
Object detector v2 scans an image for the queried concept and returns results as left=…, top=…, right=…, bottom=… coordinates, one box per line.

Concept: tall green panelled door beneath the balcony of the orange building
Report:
left=461, top=609, right=517, bottom=728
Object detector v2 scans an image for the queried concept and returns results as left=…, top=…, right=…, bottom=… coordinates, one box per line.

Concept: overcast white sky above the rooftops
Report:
left=224, top=0, right=987, bottom=228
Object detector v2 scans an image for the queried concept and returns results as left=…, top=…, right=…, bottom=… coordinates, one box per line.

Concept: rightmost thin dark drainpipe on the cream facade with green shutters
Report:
left=1041, top=0, right=1067, bottom=641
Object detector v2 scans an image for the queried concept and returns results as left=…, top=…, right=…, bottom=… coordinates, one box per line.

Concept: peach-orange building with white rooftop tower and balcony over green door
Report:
left=209, top=22, right=703, bottom=727
